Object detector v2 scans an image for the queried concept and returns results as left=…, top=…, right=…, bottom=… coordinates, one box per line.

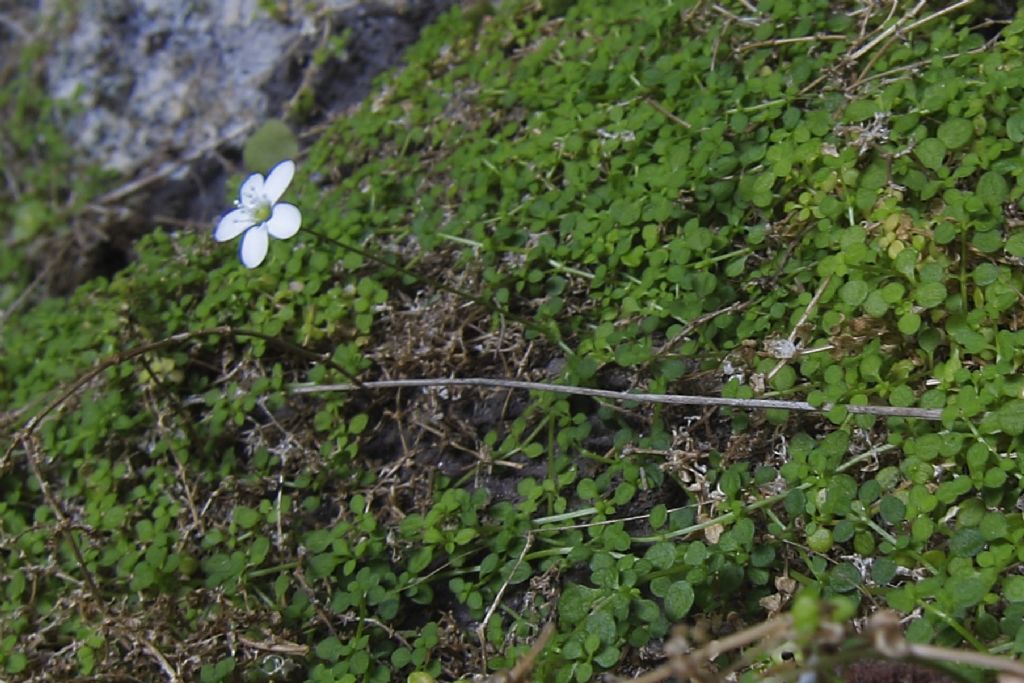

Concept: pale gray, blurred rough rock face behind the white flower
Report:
left=46, top=0, right=303, bottom=175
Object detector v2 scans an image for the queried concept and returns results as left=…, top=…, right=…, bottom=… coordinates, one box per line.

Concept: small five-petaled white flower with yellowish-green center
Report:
left=213, top=161, right=302, bottom=268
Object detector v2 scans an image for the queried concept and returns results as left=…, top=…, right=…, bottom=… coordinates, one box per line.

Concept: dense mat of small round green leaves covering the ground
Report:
left=0, top=0, right=1024, bottom=683
